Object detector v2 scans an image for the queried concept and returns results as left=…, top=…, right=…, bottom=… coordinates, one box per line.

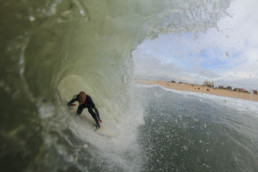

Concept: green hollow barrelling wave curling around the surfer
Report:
left=1, top=0, right=229, bottom=171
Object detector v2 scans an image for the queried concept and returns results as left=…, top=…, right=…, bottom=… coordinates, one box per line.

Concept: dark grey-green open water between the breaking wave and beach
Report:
left=138, top=86, right=258, bottom=171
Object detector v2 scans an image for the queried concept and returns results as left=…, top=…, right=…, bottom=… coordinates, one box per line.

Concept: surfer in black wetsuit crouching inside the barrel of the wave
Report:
left=67, top=91, right=102, bottom=128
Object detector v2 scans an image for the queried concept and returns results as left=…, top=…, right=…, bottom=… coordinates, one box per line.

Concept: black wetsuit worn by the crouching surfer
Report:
left=67, top=94, right=100, bottom=127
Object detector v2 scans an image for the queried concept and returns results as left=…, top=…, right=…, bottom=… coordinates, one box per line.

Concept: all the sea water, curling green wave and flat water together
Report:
left=0, top=0, right=258, bottom=172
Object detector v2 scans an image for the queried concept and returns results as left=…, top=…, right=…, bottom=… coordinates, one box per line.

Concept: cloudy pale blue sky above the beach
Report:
left=133, top=0, right=258, bottom=90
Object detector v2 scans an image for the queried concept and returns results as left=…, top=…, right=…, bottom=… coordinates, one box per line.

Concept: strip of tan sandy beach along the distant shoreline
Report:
left=135, top=79, right=258, bottom=101
